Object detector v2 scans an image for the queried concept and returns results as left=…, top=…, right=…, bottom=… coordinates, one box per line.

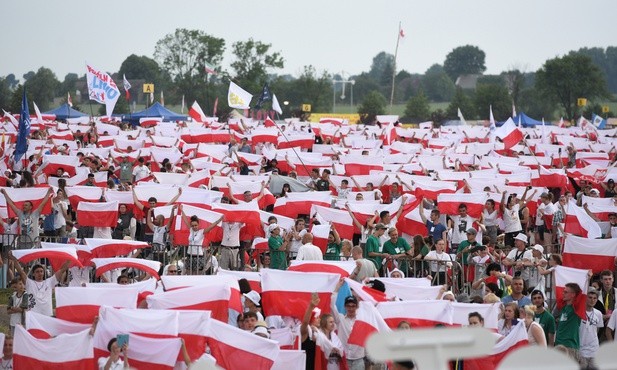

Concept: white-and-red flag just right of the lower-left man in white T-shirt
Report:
left=55, top=284, right=139, bottom=324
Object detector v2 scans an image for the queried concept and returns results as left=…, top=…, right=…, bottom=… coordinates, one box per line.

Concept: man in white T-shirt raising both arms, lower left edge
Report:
left=11, top=256, right=70, bottom=316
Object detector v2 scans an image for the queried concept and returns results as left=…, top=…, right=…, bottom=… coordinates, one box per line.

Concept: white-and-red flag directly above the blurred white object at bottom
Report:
left=377, top=300, right=452, bottom=329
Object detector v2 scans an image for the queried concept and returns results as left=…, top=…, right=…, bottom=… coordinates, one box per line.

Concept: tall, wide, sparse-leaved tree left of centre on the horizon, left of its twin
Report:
left=153, top=28, right=225, bottom=80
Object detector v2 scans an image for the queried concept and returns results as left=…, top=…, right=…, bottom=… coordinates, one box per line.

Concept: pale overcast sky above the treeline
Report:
left=0, top=0, right=617, bottom=81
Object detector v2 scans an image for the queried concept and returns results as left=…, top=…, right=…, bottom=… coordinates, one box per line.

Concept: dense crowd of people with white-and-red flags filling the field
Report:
left=0, top=113, right=617, bottom=369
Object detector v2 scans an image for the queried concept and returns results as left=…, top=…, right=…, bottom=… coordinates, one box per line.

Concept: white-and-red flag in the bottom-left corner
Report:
left=13, top=325, right=95, bottom=370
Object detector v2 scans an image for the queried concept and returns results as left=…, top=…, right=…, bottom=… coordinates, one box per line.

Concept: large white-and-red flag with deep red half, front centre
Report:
left=261, top=269, right=340, bottom=319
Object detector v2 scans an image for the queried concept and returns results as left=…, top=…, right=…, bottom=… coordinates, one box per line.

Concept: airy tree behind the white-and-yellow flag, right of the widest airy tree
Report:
left=231, top=38, right=285, bottom=92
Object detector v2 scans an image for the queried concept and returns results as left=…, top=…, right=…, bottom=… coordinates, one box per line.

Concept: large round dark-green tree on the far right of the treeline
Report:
left=536, top=54, right=608, bottom=119
